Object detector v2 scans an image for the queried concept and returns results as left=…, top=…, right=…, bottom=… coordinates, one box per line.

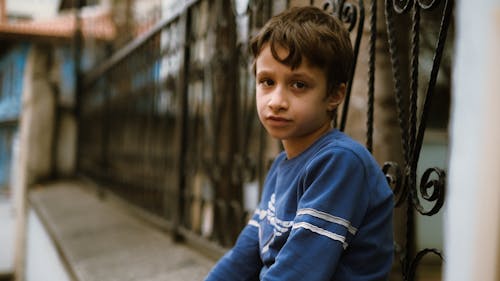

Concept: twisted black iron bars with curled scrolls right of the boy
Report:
left=383, top=0, right=452, bottom=280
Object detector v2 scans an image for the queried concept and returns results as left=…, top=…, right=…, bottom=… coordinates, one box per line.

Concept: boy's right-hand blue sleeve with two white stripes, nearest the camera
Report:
left=261, top=149, right=368, bottom=281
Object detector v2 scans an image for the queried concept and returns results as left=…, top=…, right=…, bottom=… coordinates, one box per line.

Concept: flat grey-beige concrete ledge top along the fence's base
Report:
left=30, top=181, right=215, bottom=281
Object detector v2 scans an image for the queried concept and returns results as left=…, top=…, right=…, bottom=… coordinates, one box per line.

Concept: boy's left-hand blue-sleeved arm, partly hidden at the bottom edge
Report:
left=205, top=220, right=262, bottom=281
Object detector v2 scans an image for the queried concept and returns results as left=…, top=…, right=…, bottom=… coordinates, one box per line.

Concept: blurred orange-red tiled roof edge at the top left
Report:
left=0, top=10, right=116, bottom=40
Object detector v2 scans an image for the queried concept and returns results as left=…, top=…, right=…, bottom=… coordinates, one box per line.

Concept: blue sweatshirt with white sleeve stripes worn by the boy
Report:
left=206, top=130, right=393, bottom=281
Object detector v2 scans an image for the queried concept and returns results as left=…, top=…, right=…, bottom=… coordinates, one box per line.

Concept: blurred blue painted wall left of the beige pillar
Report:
left=0, top=44, right=30, bottom=189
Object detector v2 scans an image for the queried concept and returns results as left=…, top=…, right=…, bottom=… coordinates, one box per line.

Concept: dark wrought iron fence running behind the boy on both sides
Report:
left=78, top=0, right=452, bottom=280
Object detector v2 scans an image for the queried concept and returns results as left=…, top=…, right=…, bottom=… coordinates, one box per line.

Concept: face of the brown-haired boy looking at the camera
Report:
left=255, top=44, right=342, bottom=153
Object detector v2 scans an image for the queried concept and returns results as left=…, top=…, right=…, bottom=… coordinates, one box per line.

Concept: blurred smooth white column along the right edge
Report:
left=444, top=0, right=500, bottom=281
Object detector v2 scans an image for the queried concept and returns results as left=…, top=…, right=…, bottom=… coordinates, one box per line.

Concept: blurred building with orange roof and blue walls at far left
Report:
left=0, top=0, right=116, bottom=274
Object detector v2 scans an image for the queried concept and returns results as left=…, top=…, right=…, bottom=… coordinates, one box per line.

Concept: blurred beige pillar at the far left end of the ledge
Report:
left=12, top=43, right=56, bottom=280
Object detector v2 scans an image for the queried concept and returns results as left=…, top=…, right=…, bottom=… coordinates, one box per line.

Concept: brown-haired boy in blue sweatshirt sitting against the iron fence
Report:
left=206, top=4, right=393, bottom=281
